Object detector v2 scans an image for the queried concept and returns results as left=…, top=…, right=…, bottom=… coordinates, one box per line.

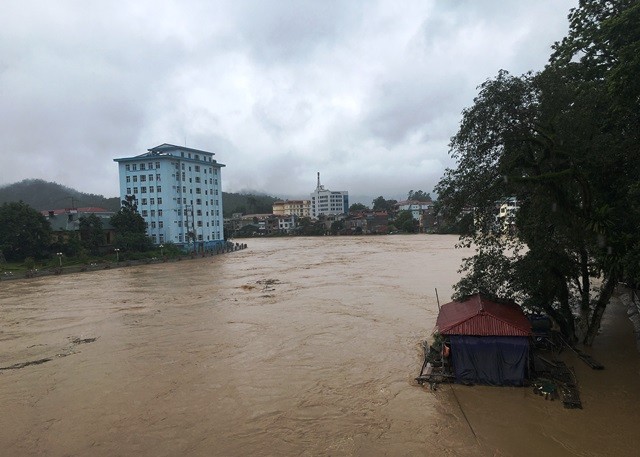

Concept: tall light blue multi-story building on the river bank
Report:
left=113, top=143, right=224, bottom=249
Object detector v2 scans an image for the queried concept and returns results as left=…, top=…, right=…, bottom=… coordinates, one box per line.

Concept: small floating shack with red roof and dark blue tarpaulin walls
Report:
left=436, top=294, right=531, bottom=386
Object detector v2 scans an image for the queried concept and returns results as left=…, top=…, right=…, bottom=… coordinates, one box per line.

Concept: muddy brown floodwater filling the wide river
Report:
left=0, top=235, right=640, bottom=456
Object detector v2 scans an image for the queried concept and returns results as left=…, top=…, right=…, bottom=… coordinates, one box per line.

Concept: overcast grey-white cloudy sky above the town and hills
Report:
left=0, top=0, right=578, bottom=204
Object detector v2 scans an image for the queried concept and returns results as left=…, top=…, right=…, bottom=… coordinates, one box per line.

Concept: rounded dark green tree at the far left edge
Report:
left=0, top=201, right=51, bottom=261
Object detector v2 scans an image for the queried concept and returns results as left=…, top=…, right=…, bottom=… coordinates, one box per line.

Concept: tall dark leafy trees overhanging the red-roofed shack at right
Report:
left=436, top=0, right=640, bottom=344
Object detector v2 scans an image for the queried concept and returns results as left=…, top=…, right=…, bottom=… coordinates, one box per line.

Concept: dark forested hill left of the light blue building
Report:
left=0, top=179, right=120, bottom=211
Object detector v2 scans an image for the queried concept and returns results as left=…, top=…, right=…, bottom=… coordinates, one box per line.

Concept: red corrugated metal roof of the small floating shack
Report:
left=436, top=294, right=531, bottom=336
